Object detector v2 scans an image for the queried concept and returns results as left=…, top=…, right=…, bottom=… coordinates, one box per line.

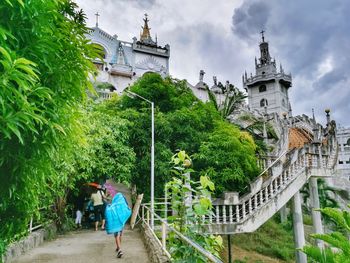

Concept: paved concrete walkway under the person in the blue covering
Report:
left=13, top=226, right=150, bottom=263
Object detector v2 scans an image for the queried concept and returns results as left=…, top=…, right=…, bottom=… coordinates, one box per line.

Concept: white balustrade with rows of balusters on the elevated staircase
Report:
left=203, top=141, right=337, bottom=234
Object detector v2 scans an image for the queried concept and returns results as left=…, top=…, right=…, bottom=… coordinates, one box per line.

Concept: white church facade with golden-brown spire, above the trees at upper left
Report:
left=87, top=14, right=170, bottom=93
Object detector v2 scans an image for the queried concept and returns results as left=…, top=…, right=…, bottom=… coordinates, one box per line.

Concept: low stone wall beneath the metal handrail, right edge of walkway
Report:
left=140, top=225, right=171, bottom=263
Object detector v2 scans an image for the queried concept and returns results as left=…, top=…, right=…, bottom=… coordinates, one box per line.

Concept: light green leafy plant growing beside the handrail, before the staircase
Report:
left=166, top=151, right=222, bottom=262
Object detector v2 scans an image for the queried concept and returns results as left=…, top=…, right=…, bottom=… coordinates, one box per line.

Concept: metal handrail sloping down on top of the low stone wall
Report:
left=141, top=206, right=222, bottom=263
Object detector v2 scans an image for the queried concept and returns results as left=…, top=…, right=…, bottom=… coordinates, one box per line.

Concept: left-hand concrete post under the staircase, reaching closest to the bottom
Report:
left=293, top=191, right=307, bottom=263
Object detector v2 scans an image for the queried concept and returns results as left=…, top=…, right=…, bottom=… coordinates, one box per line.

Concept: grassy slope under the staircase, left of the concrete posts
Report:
left=233, top=219, right=295, bottom=261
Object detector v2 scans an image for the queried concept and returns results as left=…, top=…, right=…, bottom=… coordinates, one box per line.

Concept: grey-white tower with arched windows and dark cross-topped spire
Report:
left=242, top=31, right=292, bottom=116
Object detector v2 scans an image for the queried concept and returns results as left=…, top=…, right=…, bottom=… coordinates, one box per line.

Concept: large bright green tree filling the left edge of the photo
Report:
left=0, top=0, right=96, bottom=252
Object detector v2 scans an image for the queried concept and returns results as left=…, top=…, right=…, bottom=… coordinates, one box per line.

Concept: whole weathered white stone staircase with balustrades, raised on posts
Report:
left=202, top=134, right=338, bottom=234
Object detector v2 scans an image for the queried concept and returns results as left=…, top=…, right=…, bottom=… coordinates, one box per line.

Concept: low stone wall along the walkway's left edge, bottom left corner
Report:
left=1, top=225, right=57, bottom=263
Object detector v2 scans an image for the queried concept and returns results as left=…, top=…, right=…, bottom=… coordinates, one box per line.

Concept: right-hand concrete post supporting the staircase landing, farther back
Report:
left=309, top=177, right=324, bottom=249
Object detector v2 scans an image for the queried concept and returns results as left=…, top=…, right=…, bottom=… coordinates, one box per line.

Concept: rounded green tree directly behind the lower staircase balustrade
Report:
left=194, top=121, right=259, bottom=193
